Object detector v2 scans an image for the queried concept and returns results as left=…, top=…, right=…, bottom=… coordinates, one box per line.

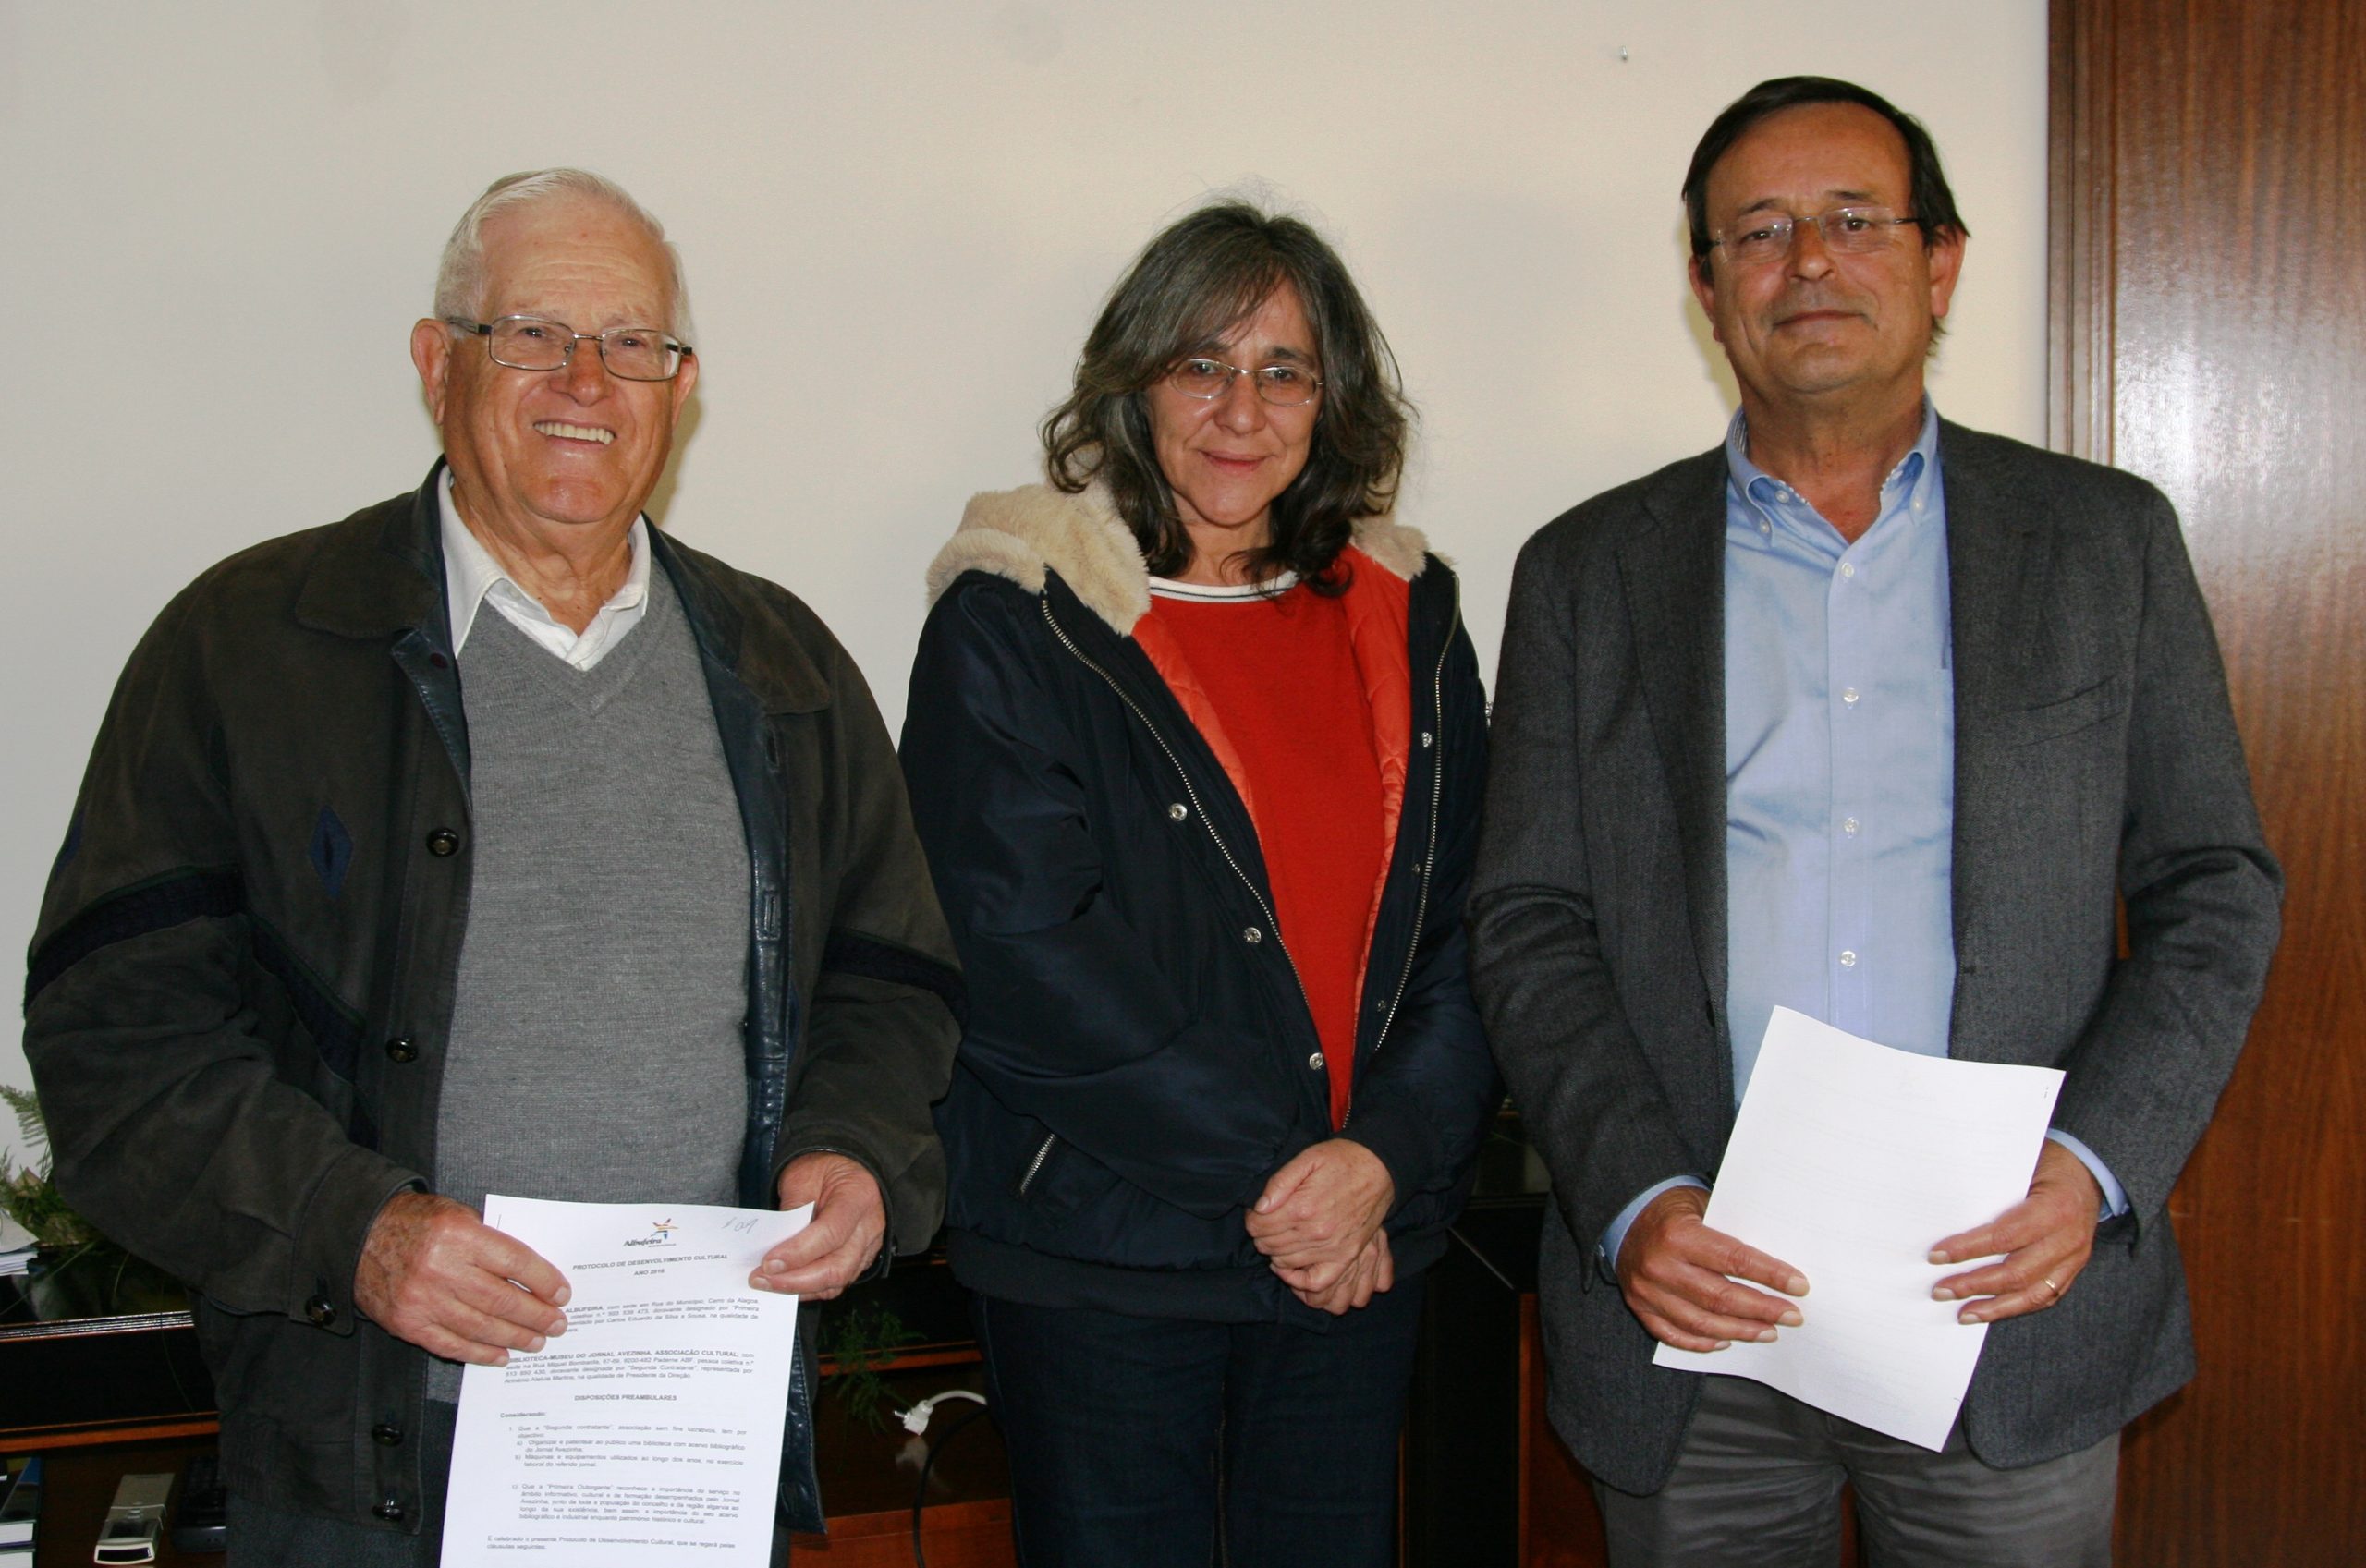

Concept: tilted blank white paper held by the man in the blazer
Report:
left=1652, top=1007, right=2063, bottom=1450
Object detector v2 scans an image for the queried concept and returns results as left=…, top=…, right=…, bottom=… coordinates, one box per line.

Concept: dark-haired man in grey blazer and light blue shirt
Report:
left=1471, top=78, right=2281, bottom=1565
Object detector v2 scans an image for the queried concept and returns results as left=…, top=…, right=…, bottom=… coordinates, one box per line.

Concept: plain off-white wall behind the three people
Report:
left=0, top=0, right=2046, bottom=1177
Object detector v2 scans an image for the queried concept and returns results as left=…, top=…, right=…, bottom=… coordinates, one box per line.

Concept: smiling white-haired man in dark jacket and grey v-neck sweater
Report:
left=24, top=170, right=960, bottom=1563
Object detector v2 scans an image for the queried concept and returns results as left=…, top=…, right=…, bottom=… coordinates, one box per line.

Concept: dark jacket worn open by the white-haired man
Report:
left=24, top=468, right=958, bottom=1530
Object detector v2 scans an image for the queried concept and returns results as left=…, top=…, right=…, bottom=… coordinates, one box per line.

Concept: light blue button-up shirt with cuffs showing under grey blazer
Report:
left=1602, top=402, right=2127, bottom=1258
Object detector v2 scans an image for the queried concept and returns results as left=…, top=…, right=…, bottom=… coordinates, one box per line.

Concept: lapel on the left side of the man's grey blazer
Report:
left=1618, top=447, right=1732, bottom=1074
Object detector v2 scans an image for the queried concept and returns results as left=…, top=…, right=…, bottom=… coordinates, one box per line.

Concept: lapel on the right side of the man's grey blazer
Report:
left=1940, top=421, right=2049, bottom=1062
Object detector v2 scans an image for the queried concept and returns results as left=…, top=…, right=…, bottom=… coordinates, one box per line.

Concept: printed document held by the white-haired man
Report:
left=443, top=1195, right=814, bottom=1568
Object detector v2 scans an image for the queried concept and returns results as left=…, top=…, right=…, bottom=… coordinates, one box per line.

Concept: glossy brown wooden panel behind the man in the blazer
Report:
left=2052, top=0, right=2366, bottom=1568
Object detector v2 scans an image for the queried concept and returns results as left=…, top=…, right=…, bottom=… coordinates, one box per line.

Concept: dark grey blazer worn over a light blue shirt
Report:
left=1470, top=423, right=2283, bottom=1492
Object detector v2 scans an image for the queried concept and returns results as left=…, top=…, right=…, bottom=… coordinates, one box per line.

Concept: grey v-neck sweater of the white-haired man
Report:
left=428, top=567, right=748, bottom=1400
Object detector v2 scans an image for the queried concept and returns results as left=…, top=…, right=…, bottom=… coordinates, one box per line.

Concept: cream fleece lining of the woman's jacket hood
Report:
left=928, top=485, right=1429, bottom=637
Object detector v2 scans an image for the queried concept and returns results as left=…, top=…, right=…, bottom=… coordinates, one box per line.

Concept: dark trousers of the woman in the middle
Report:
left=972, top=1280, right=1422, bottom=1568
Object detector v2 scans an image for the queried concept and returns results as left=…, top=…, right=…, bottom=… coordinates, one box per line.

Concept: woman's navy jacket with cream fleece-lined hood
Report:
left=901, top=487, right=1500, bottom=1327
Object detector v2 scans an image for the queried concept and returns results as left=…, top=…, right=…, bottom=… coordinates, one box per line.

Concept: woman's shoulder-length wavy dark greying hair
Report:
left=1041, top=201, right=1412, bottom=593
